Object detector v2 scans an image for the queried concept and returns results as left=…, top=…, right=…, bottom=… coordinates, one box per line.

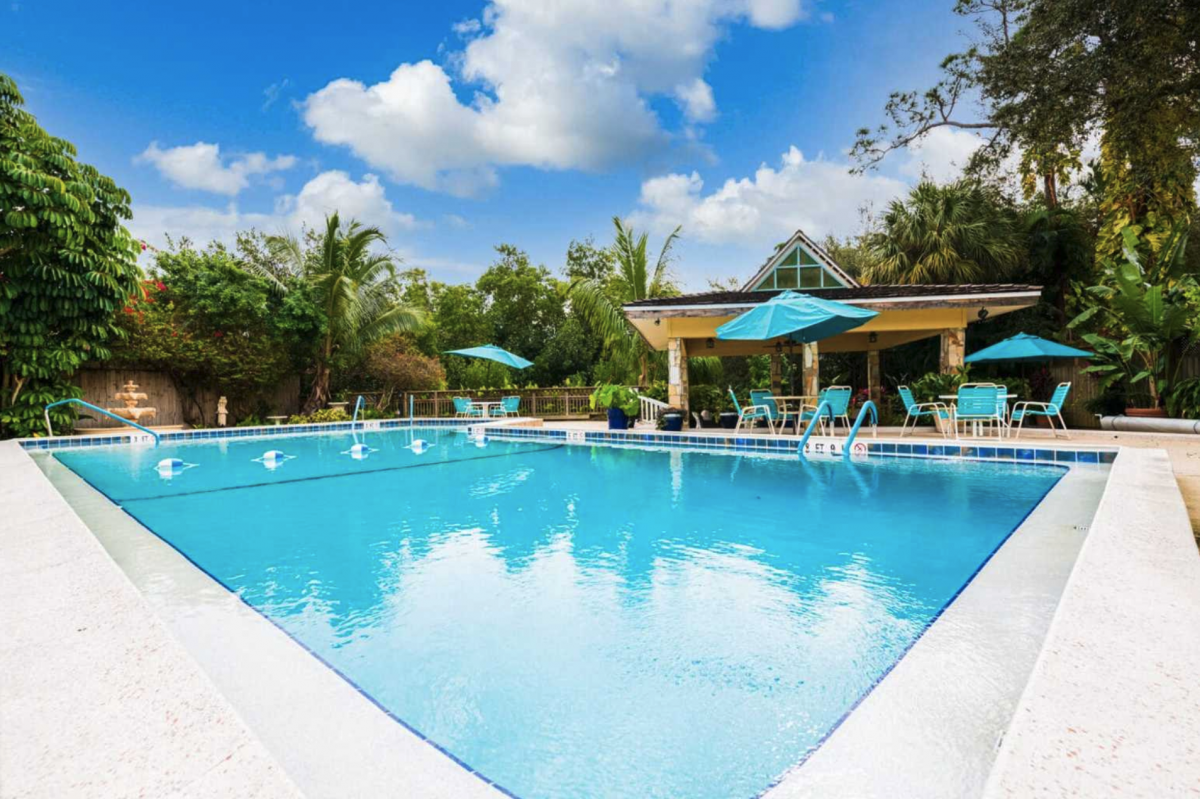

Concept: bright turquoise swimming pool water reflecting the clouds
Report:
left=55, top=428, right=1063, bottom=799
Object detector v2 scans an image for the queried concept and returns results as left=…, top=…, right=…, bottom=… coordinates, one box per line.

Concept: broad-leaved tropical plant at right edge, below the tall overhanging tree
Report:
left=1067, top=228, right=1198, bottom=417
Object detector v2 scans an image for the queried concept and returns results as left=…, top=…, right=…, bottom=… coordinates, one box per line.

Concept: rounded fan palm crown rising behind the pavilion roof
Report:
left=862, top=181, right=1022, bottom=283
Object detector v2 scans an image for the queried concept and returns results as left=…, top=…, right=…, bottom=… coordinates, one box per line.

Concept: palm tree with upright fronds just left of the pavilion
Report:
left=566, top=216, right=680, bottom=385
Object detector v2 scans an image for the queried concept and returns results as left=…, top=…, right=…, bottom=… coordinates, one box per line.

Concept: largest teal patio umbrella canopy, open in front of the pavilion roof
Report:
left=716, top=292, right=878, bottom=343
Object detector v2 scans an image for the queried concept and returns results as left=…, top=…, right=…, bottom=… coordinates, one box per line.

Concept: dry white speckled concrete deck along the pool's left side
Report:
left=0, top=441, right=302, bottom=799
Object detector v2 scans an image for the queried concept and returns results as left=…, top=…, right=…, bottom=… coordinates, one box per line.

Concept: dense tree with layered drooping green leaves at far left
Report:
left=0, top=73, right=140, bottom=437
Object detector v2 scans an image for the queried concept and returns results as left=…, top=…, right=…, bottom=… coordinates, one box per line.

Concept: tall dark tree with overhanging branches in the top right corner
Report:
left=852, top=0, right=1200, bottom=271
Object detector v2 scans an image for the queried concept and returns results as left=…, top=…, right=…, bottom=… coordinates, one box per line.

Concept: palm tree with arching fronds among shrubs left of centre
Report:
left=257, top=214, right=422, bottom=414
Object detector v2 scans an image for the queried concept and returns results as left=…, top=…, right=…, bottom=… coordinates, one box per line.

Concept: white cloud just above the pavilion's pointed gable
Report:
left=630, top=146, right=907, bottom=242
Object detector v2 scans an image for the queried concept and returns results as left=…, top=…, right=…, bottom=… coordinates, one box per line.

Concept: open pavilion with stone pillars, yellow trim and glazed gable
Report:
left=624, top=230, right=1042, bottom=417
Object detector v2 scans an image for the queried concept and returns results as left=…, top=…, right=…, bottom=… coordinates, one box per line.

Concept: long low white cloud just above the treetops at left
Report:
left=128, top=170, right=420, bottom=246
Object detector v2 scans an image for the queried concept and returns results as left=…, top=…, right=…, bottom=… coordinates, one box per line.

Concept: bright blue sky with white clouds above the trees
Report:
left=0, top=0, right=993, bottom=290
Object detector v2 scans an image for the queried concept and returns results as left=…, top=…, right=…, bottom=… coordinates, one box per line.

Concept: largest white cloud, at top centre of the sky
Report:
left=304, top=0, right=805, bottom=194
